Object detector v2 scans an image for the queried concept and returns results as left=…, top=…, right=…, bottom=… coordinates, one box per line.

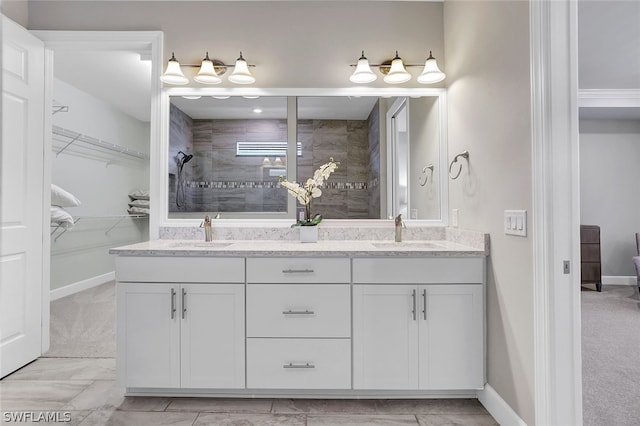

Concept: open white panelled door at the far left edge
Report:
left=0, top=16, right=49, bottom=377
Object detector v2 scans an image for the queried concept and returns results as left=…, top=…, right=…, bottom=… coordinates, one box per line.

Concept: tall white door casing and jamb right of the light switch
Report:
left=529, top=0, right=582, bottom=425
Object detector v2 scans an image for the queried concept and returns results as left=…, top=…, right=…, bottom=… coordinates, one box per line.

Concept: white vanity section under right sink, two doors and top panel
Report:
left=353, top=258, right=485, bottom=390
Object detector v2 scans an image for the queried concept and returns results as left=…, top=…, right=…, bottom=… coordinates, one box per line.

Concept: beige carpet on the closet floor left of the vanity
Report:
left=44, top=281, right=116, bottom=358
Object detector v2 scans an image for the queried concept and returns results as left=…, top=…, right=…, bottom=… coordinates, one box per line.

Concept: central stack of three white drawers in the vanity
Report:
left=247, top=258, right=351, bottom=389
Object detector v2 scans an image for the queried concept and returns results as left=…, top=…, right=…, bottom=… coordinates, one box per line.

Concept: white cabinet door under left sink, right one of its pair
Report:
left=179, top=284, right=245, bottom=388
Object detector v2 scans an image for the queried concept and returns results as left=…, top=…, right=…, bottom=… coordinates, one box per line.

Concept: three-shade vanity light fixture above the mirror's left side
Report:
left=160, top=52, right=256, bottom=85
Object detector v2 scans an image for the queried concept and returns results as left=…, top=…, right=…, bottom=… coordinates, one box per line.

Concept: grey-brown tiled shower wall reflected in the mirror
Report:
left=169, top=102, right=380, bottom=219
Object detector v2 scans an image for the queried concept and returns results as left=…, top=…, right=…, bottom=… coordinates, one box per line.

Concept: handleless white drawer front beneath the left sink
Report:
left=116, top=256, right=244, bottom=283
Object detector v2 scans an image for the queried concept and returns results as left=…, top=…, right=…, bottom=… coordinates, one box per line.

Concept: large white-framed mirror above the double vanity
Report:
left=161, top=89, right=447, bottom=225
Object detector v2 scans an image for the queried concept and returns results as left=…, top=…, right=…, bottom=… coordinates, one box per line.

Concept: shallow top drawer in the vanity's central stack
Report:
left=247, top=257, right=351, bottom=284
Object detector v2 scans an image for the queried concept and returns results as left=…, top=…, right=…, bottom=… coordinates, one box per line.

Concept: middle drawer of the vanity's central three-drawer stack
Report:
left=247, top=284, right=351, bottom=337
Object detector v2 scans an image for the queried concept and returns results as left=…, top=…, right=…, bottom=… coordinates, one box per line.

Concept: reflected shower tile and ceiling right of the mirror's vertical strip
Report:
left=297, top=96, right=381, bottom=219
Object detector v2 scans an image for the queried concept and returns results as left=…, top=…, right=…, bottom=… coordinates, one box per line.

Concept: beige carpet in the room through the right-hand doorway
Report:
left=581, top=285, right=640, bottom=426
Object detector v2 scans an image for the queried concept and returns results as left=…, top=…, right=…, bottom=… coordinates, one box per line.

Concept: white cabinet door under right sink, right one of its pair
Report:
left=419, top=284, right=484, bottom=390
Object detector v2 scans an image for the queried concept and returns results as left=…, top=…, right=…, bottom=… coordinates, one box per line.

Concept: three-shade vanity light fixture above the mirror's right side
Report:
left=349, top=50, right=446, bottom=84
